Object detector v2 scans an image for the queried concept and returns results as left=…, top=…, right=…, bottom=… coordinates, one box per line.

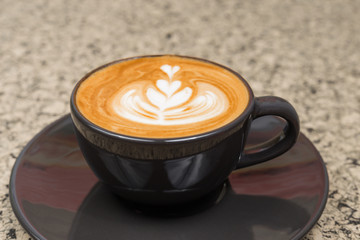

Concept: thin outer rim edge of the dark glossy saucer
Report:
left=9, top=113, right=329, bottom=240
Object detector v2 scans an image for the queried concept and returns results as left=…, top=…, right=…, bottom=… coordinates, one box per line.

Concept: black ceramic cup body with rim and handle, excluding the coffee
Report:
left=70, top=56, right=299, bottom=205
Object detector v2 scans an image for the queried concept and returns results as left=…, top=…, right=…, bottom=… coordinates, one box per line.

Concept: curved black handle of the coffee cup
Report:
left=236, top=96, right=300, bottom=168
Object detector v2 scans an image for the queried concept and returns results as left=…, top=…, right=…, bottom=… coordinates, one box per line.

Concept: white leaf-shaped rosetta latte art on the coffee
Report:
left=112, top=64, right=229, bottom=126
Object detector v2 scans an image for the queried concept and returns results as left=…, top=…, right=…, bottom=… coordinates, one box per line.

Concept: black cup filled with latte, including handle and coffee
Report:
left=70, top=55, right=299, bottom=205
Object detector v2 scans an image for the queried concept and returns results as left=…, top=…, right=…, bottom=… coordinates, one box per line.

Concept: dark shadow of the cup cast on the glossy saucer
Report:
left=68, top=182, right=310, bottom=240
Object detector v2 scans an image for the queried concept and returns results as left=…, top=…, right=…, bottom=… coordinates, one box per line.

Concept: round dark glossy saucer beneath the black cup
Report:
left=10, top=115, right=328, bottom=240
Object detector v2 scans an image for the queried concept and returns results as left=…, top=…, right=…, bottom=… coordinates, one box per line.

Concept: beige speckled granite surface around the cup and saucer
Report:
left=0, top=0, right=360, bottom=239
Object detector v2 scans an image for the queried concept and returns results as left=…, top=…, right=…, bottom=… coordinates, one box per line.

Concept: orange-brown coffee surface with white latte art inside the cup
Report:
left=75, top=56, right=249, bottom=138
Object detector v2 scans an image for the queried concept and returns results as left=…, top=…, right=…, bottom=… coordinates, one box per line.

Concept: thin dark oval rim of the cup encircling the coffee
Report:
left=70, top=54, right=254, bottom=144
